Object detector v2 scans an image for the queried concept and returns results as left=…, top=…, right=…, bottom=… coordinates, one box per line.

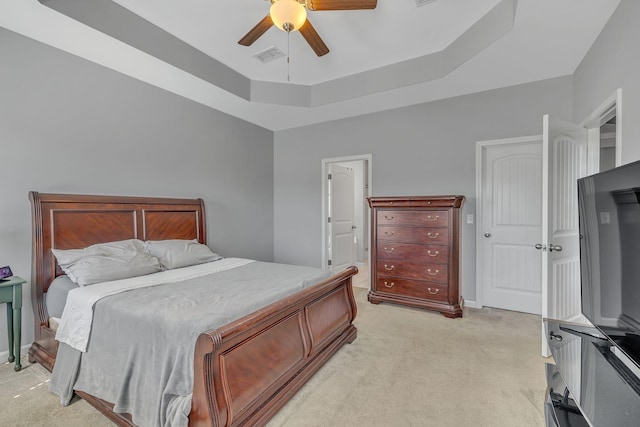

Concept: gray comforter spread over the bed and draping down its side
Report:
left=49, top=262, right=329, bottom=427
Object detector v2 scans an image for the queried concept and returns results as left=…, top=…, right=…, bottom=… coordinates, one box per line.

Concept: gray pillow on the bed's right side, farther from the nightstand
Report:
left=145, top=239, right=222, bottom=270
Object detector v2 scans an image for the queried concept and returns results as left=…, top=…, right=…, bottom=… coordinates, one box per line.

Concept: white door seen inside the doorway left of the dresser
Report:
left=328, top=164, right=356, bottom=271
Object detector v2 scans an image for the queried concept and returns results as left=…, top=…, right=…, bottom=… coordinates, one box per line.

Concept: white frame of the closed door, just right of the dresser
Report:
left=476, top=134, right=542, bottom=308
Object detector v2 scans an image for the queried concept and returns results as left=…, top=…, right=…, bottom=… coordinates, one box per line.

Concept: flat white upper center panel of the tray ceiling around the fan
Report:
left=116, top=0, right=500, bottom=85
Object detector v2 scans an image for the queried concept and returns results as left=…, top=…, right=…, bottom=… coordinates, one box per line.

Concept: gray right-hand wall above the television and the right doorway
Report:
left=573, top=0, right=640, bottom=163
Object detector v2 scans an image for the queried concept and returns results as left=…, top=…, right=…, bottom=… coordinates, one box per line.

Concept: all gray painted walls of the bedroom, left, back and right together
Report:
left=0, top=0, right=640, bottom=352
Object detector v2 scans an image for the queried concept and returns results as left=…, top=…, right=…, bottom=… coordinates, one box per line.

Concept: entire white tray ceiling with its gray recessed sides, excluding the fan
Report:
left=0, top=0, right=620, bottom=131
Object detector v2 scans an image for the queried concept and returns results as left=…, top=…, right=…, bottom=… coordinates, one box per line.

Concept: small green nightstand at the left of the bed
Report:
left=0, top=276, right=27, bottom=371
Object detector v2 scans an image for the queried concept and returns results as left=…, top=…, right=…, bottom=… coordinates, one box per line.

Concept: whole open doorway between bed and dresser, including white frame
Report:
left=322, top=154, right=371, bottom=287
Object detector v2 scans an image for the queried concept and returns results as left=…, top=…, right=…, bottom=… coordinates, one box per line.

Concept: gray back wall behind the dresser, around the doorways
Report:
left=274, top=77, right=572, bottom=303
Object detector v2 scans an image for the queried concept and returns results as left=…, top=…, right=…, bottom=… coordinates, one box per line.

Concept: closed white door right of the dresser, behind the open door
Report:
left=479, top=138, right=542, bottom=314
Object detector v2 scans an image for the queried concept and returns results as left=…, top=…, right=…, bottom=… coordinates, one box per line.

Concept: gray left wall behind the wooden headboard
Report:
left=0, top=28, right=273, bottom=354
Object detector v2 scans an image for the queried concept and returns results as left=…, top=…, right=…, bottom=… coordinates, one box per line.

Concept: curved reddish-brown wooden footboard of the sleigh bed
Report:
left=189, top=267, right=357, bottom=426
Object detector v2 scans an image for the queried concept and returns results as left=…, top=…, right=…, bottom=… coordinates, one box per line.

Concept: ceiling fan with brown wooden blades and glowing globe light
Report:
left=238, top=0, right=378, bottom=56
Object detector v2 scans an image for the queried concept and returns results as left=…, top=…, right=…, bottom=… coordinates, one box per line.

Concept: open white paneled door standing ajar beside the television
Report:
left=538, top=115, right=587, bottom=356
